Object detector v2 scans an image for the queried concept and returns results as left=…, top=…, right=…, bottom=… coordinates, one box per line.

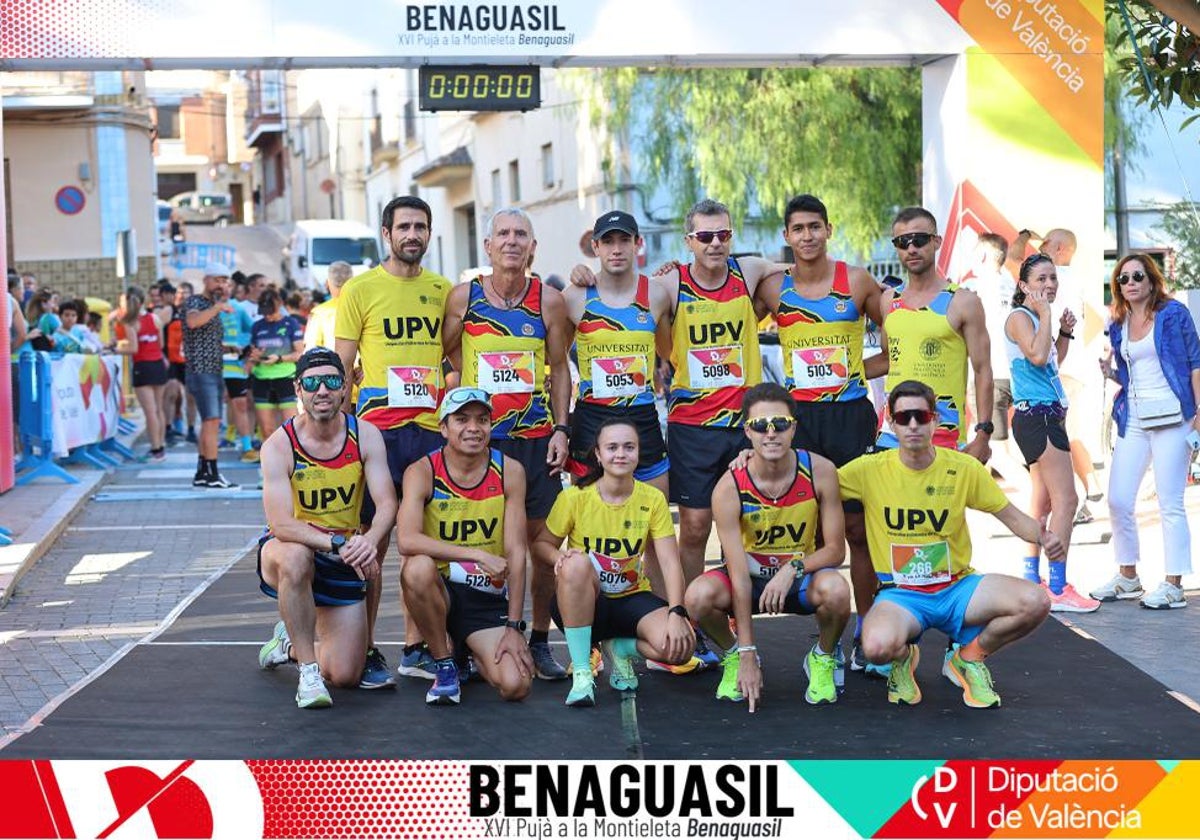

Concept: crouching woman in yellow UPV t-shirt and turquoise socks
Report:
left=532, top=418, right=696, bottom=706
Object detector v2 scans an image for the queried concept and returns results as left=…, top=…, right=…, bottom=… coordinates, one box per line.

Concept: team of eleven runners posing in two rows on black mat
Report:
left=259, top=196, right=1066, bottom=712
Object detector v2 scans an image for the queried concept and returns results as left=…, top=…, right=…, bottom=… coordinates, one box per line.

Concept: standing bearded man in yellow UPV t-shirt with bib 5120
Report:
left=335, top=196, right=450, bottom=688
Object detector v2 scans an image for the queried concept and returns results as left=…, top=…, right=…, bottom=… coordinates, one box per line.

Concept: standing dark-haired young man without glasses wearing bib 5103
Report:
left=758, top=194, right=882, bottom=670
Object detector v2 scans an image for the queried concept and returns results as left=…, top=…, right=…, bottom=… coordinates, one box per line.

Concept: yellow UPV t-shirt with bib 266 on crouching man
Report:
left=838, top=446, right=1008, bottom=592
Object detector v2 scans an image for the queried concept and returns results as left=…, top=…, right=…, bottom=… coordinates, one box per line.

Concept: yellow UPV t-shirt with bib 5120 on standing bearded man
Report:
left=334, top=266, right=450, bottom=431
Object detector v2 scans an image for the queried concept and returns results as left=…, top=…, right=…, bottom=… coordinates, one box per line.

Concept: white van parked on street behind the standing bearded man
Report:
left=281, top=218, right=379, bottom=292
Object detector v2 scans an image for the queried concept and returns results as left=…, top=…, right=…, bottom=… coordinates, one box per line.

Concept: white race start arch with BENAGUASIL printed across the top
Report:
left=0, top=0, right=1104, bottom=490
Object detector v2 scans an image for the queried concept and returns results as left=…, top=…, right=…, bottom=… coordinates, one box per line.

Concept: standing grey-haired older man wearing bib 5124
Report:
left=442, top=208, right=571, bottom=679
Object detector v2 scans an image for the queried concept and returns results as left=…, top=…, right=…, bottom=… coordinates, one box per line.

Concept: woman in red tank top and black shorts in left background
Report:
left=114, top=286, right=167, bottom=461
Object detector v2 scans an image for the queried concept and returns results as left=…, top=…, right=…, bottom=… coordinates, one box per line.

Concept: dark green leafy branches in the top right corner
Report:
left=1104, top=0, right=1200, bottom=128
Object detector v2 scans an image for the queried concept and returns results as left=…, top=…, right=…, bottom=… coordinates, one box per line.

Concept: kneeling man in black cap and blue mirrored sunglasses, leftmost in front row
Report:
left=258, top=347, right=396, bottom=709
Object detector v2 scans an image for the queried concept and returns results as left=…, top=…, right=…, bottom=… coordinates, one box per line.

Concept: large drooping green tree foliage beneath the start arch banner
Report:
left=568, top=67, right=922, bottom=253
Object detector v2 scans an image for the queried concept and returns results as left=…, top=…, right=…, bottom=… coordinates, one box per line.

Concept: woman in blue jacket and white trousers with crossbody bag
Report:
left=1092, top=254, right=1200, bottom=610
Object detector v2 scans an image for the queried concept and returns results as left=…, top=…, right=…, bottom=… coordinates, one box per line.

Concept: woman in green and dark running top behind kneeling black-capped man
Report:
left=250, top=286, right=304, bottom=440
